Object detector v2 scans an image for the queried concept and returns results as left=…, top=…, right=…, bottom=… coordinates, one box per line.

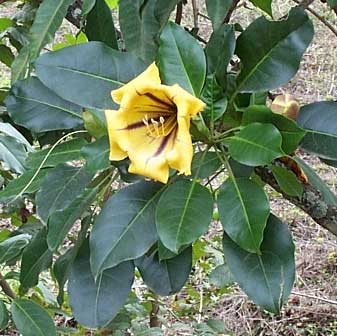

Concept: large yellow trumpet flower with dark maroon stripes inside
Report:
left=105, top=63, right=205, bottom=183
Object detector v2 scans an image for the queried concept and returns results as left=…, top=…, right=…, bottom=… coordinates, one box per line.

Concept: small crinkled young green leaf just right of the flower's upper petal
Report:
left=202, top=75, right=227, bottom=123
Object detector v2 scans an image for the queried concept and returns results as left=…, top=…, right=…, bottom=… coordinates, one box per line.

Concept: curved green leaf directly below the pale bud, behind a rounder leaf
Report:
left=241, top=105, right=305, bottom=154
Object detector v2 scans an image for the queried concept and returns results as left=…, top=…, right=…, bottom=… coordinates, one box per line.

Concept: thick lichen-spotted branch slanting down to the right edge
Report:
left=255, top=167, right=337, bottom=236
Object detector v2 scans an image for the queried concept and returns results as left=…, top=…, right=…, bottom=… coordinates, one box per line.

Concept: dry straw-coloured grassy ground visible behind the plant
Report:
left=0, top=0, right=337, bottom=336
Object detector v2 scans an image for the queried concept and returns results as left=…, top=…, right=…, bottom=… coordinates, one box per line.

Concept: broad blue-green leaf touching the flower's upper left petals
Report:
left=35, top=42, right=144, bottom=109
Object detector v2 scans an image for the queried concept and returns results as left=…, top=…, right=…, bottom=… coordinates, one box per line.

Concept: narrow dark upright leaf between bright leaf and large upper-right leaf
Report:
left=205, top=24, right=236, bottom=87
